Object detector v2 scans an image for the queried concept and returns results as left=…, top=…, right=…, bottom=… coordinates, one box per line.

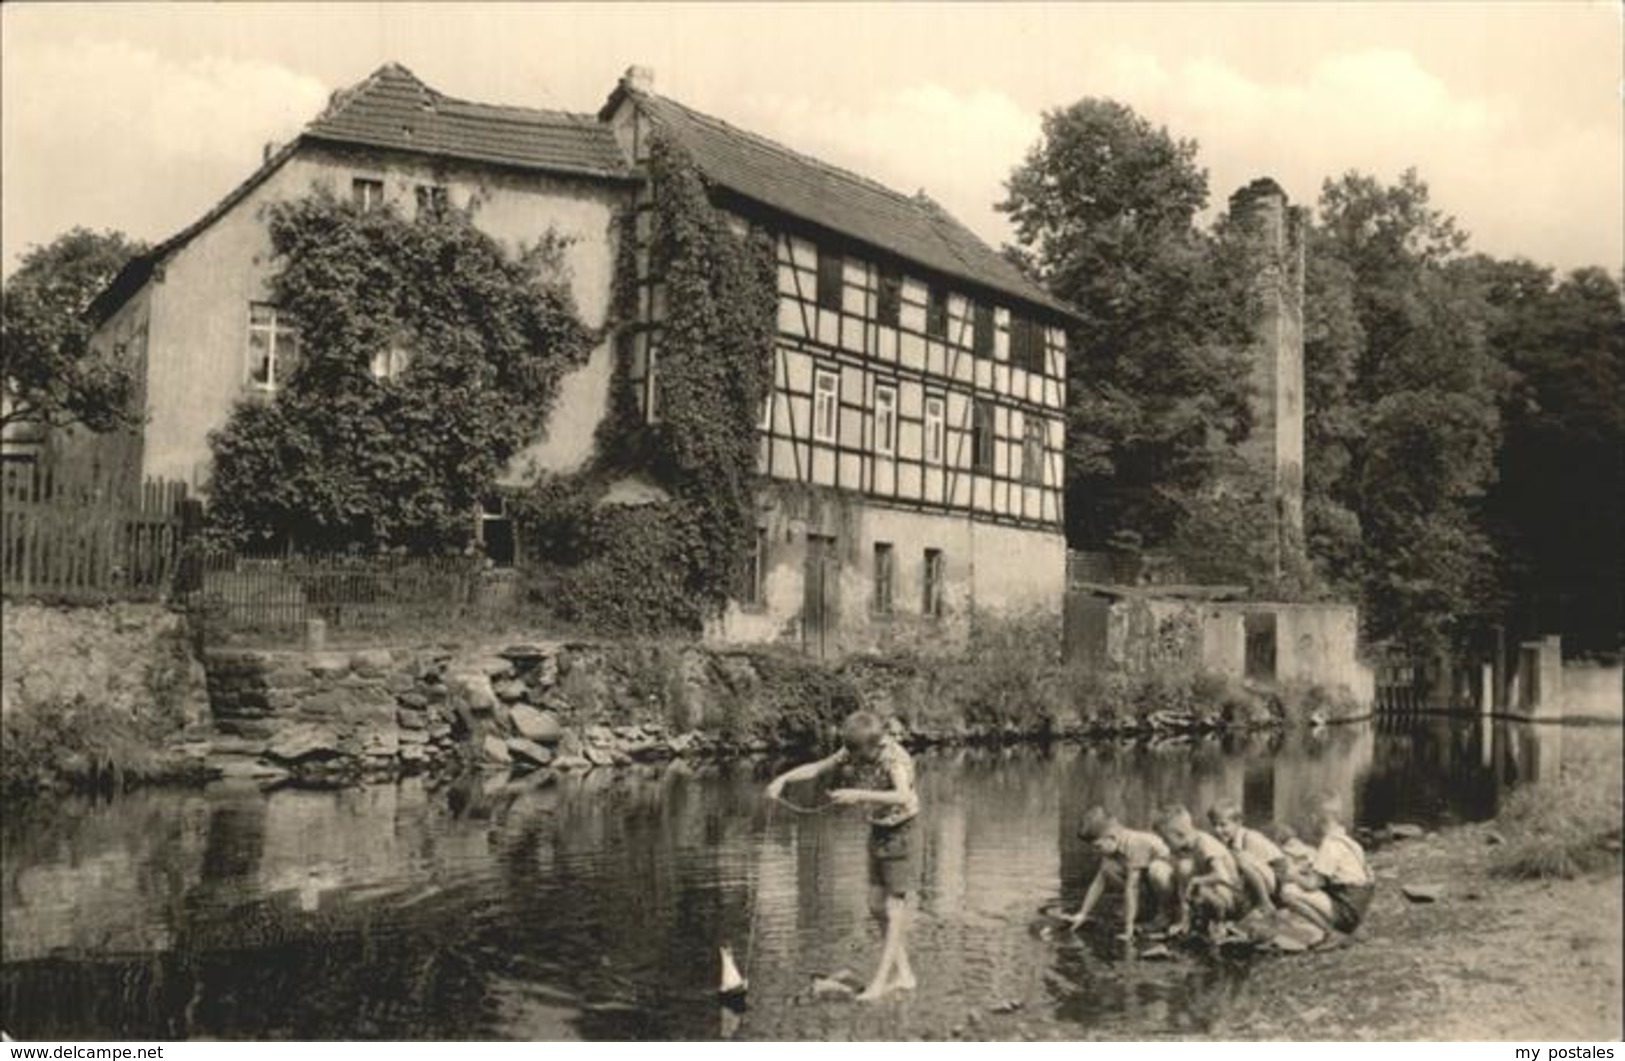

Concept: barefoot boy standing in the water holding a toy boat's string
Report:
left=767, top=712, right=920, bottom=1001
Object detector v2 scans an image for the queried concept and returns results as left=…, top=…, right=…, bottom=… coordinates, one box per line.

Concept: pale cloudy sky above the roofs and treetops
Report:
left=0, top=0, right=1625, bottom=273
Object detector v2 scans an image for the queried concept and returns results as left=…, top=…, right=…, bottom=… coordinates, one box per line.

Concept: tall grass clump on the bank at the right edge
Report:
left=1492, top=737, right=1625, bottom=881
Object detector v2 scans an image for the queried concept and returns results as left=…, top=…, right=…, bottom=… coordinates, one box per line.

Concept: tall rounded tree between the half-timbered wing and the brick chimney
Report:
left=999, top=99, right=1255, bottom=548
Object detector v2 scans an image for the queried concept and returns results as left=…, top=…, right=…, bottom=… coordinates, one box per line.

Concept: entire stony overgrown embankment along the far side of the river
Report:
left=5, top=606, right=1360, bottom=790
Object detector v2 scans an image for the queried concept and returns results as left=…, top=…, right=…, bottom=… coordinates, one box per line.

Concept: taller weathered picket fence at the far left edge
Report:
left=0, top=461, right=187, bottom=601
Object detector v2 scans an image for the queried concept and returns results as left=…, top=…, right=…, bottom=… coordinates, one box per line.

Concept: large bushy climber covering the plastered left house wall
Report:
left=210, top=193, right=593, bottom=552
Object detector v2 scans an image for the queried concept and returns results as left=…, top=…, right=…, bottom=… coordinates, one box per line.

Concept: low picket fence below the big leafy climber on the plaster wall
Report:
left=182, top=551, right=517, bottom=634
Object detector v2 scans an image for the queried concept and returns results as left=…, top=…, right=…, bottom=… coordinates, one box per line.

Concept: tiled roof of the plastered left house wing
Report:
left=306, top=63, right=629, bottom=177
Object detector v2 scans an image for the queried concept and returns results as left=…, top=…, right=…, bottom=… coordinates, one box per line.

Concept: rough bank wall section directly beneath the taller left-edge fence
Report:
left=0, top=601, right=208, bottom=795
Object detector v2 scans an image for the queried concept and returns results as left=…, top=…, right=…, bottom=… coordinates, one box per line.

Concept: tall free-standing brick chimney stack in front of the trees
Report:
left=1230, top=177, right=1305, bottom=574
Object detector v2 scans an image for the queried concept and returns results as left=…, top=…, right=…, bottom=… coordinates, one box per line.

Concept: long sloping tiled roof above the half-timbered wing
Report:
left=622, top=89, right=1074, bottom=317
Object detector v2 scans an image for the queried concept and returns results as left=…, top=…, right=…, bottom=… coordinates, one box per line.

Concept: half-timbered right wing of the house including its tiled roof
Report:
left=601, top=70, right=1071, bottom=653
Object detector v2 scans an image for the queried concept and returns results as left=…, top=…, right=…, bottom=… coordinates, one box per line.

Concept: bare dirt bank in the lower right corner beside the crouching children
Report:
left=1214, top=825, right=1625, bottom=1043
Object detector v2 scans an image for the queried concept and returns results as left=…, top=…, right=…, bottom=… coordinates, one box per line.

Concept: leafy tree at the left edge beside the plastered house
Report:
left=0, top=227, right=145, bottom=432
